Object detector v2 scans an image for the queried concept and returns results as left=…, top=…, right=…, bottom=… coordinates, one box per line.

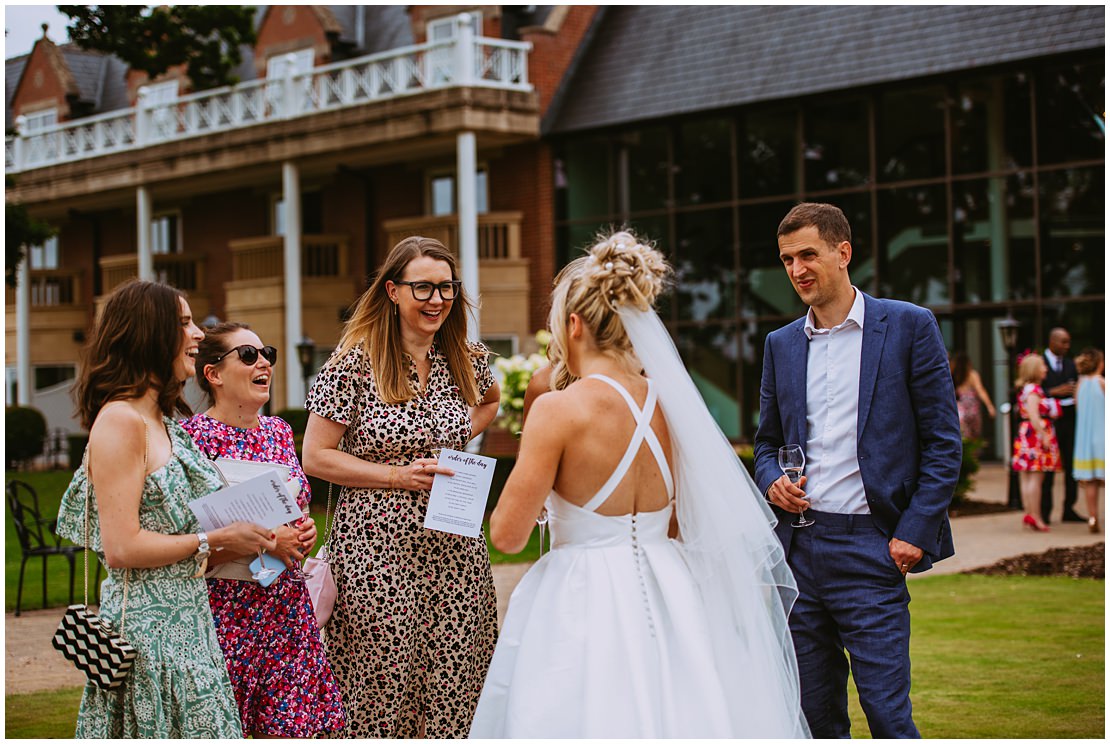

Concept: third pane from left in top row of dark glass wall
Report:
left=675, top=119, right=733, bottom=204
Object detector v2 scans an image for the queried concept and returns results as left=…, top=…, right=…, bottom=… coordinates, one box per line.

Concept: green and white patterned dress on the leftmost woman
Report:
left=58, top=419, right=243, bottom=738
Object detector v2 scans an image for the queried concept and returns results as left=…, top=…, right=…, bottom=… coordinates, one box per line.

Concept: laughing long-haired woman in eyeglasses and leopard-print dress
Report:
left=304, top=238, right=501, bottom=738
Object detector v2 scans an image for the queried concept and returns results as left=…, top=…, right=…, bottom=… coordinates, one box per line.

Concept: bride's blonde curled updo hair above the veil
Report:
left=547, top=230, right=672, bottom=390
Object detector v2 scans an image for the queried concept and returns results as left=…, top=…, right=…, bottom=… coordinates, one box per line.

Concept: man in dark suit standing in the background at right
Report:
left=1041, top=328, right=1087, bottom=524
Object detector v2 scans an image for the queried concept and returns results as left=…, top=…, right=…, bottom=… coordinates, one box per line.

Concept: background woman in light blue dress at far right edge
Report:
left=1072, top=349, right=1107, bottom=532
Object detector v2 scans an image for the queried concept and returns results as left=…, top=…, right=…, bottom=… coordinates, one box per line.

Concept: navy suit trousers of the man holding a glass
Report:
left=787, top=510, right=920, bottom=738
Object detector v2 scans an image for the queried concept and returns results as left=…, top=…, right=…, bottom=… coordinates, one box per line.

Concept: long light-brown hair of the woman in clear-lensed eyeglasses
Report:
left=327, top=235, right=480, bottom=405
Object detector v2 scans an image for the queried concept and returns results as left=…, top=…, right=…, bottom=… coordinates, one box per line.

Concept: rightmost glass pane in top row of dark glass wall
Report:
left=1037, top=61, right=1106, bottom=163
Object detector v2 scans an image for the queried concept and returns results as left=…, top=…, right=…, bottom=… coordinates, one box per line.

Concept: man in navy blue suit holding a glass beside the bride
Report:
left=755, top=203, right=962, bottom=738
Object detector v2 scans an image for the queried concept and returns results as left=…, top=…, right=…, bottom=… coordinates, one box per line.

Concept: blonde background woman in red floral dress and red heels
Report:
left=1013, top=354, right=1060, bottom=532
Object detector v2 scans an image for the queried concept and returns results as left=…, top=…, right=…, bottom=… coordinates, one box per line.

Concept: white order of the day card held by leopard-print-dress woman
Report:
left=424, top=450, right=497, bottom=537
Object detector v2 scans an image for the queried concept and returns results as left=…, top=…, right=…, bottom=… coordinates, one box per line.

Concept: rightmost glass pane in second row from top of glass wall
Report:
left=1040, top=168, right=1106, bottom=298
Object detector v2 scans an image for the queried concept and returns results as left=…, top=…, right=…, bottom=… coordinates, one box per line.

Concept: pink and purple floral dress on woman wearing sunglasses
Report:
left=181, top=414, right=345, bottom=738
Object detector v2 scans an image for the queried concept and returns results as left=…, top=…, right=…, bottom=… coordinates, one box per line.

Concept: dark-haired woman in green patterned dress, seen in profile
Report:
left=58, top=281, right=274, bottom=738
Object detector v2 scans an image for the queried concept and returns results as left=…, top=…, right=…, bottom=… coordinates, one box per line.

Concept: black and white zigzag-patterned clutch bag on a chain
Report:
left=53, top=604, right=135, bottom=690
